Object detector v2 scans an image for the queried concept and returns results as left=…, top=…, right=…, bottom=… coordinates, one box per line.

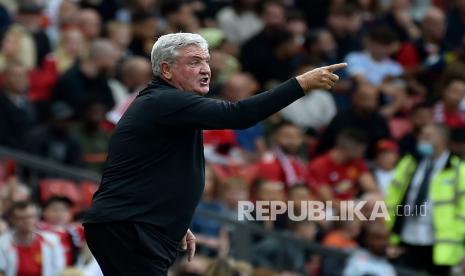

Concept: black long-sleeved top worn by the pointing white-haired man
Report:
left=85, top=78, right=304, bottom=242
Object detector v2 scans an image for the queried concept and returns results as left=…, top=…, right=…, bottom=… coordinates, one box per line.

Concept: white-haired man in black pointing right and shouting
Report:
left=84, top=33, right=345, bottom=275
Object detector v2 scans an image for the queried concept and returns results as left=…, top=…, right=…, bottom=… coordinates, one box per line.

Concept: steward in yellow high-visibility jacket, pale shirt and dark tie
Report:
left=386, top=124, right=465, bottom=275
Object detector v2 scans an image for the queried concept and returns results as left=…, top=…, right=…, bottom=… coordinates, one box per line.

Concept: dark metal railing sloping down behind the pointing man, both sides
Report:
left=0, top=146, right=427, bottom=276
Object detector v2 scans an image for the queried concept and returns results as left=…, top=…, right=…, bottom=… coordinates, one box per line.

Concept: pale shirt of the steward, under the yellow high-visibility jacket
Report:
left=401, top=151, right=450, bottom=246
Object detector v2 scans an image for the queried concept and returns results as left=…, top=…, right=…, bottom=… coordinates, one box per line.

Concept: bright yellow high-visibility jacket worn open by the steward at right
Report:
left=385, top=155, right=465, bottom=266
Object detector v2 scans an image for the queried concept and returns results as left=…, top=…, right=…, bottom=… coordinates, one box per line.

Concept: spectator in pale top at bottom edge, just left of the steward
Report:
left=343, top=223, right=397, bottom=276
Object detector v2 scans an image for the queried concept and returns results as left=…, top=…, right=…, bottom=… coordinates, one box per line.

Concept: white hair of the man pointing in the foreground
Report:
left=151, top=33, right=208, bottom=77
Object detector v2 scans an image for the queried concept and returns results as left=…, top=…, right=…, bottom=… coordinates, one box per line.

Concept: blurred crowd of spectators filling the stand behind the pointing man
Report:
left=0, top=0, right=465, bottom=276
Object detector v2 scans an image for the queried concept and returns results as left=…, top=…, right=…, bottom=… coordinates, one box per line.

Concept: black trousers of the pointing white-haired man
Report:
left=84, top=222, right=179, bottom=276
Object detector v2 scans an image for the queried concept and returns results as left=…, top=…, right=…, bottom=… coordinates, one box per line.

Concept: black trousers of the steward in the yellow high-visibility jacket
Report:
left=395, top=243, right=451, bottom=276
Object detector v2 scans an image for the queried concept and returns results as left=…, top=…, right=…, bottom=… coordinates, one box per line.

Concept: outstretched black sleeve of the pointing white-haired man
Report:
left=156, top=78, right=304, bottom=129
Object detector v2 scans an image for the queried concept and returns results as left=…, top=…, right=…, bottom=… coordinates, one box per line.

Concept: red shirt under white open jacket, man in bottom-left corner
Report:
left=15, top=235, right=43, bottom=276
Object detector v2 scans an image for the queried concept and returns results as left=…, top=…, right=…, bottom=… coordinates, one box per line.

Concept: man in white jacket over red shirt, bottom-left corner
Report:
left=0, top=201, right=65, bottom=276
